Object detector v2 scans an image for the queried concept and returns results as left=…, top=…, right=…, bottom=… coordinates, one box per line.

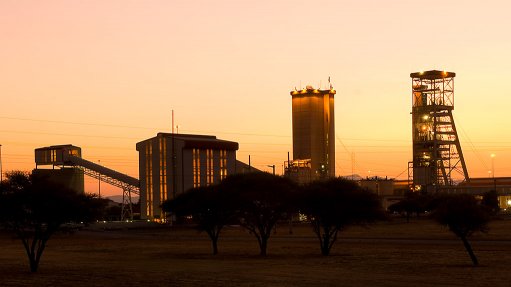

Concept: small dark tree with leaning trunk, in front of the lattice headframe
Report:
left=432, top=194, right=490, bottom=265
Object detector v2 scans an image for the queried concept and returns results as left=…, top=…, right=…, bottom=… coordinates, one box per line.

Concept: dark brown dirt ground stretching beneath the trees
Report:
left=0, top=219, right=511, bottom=286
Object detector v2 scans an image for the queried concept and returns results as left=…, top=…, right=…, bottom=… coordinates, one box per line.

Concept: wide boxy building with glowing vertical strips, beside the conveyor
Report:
left=136, top=133, right=238, bottom=220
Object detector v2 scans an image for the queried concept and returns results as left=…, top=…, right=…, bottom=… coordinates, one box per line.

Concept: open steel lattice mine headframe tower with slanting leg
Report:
left=408, top=70, right=469, bottom=192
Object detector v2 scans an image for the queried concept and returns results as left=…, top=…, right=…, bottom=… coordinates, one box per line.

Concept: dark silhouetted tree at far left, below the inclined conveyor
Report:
left=0, top=171, right=102, bottom=272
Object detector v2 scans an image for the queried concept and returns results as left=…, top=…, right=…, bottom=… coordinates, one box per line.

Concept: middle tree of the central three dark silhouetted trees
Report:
left=220, top=173, right=295, bottom=256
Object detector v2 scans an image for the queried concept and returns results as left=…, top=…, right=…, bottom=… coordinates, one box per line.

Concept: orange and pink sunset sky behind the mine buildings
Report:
left=0, top=0, right=511, bottom=197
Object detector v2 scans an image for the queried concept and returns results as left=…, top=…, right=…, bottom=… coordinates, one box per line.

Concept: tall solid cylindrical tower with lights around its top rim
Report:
left=286, top=86, right=335, bottom=183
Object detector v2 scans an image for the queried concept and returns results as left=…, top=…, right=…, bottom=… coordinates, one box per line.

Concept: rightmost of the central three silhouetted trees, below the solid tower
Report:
left=300, top=178, right=384, bottom=255
